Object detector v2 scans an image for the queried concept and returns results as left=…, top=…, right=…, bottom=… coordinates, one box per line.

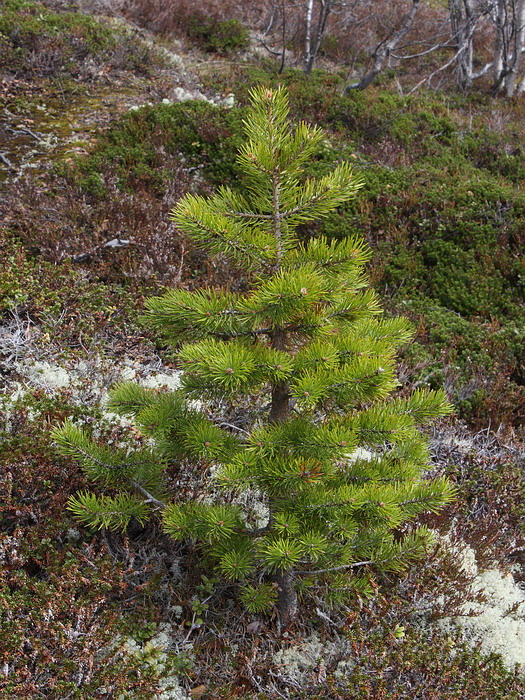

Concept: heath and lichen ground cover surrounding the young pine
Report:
left=0, top=0, right=525, bottom=700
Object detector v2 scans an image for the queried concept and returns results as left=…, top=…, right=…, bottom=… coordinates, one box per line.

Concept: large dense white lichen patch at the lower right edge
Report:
left=437, top=546, right=525, bottom=673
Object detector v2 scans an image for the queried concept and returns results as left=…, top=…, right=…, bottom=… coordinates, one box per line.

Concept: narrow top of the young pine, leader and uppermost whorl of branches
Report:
left=172, top=84, right=362, bottom=268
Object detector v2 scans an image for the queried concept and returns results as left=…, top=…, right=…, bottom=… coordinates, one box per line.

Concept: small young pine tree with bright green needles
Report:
left=55, top=88, right=453, bottom=624
